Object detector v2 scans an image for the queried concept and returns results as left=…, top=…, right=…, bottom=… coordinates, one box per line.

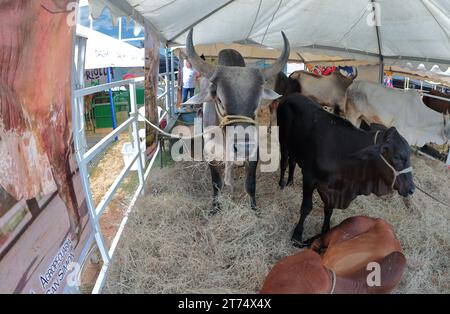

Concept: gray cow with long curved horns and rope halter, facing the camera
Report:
left=186, top=29, right=290, bottom=212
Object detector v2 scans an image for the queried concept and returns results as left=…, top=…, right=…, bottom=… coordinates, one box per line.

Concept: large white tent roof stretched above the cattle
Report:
left=89, top=0, right=450, bottom=71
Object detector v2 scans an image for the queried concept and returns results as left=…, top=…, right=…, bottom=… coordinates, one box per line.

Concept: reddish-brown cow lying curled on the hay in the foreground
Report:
left=260, top=216, right=406, bottom=294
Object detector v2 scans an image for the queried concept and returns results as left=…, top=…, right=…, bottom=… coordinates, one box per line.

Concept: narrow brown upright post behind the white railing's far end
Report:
left=144, top=26, right=159, bottom=157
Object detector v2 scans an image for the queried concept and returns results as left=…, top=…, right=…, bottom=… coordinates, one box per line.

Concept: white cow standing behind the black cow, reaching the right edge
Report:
left=344, top=81, right=450, bottom=147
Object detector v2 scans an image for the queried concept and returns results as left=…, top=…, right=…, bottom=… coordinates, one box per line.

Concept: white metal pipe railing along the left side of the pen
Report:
left=72, top=77, right=167, bottom=294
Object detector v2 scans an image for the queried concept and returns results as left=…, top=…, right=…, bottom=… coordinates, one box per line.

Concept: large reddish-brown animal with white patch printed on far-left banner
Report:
left=0, top=0, right=80, bottom=236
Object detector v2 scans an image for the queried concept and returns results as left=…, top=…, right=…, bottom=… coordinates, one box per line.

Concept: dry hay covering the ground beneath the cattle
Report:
left=104, top=151, right=450, bottom=293
